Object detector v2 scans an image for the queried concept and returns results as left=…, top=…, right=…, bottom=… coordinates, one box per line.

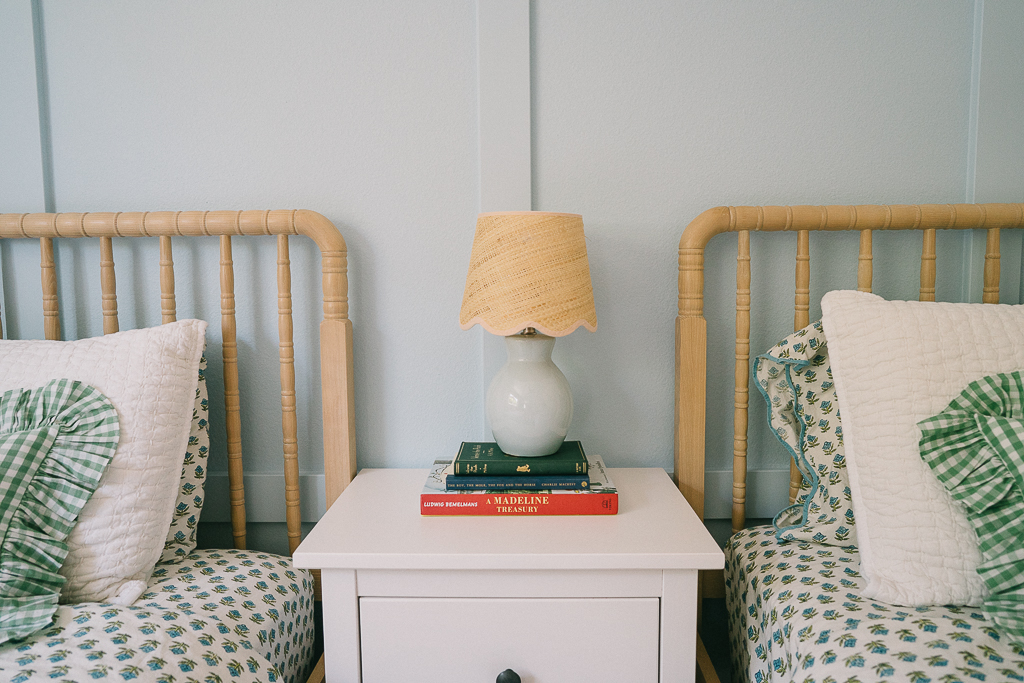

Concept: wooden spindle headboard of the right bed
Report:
left=675, top=204, right=1024, bottom=531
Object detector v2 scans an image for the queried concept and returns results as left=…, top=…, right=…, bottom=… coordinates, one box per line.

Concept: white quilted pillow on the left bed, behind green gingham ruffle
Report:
left=0, top=321, right=206, bottom=605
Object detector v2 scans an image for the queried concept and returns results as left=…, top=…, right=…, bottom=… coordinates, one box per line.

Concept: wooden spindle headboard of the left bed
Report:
left=0, top=211, right=355, bottom=552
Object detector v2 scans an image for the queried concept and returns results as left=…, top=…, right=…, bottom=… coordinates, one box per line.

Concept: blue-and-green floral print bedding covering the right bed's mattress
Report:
left=725, top=526, right=1024, bottom=683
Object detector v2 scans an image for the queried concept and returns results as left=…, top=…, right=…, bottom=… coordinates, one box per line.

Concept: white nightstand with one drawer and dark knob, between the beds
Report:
left=294, top=469, right=725, bottom=683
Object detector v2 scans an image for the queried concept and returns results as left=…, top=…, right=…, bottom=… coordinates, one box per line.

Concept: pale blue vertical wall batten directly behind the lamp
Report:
left=475, top=0, right=532, bottom=440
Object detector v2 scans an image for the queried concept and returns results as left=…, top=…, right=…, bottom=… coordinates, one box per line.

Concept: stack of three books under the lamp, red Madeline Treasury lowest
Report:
left=420, top=441, right=618, bottom=515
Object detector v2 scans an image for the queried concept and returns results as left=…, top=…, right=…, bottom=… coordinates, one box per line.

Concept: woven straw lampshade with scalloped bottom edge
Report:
left=459, top=211, right=597, bottom=337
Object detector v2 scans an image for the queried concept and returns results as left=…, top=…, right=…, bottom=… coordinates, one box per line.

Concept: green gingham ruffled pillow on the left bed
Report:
left=0, top=380, right=121, bottom=643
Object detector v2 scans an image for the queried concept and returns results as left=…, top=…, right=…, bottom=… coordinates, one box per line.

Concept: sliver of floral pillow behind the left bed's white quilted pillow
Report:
left=160, top=355, right=210, bottom=562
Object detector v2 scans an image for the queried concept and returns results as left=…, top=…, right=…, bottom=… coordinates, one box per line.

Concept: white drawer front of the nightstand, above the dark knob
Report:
left=360, top=598, right=659, bottom=683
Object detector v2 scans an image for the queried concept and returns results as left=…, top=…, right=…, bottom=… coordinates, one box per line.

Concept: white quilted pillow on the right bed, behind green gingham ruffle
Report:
left=821, top=292, right=1024, bottom=605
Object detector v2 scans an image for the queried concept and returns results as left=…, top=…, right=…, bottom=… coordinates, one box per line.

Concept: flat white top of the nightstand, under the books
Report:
left=294, top=468, right=725, bottom=569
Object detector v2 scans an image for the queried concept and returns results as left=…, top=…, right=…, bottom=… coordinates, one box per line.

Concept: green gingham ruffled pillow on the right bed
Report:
left=918, top=372, right=1024, bottom=644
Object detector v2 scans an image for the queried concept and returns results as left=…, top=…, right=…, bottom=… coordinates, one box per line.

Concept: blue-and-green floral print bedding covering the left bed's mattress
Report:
left=0, top=550, right=314, bottom=683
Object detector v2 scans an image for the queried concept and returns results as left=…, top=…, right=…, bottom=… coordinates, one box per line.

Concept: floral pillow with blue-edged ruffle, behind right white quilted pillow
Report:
left=754, top=321, right=857, bottom=547
